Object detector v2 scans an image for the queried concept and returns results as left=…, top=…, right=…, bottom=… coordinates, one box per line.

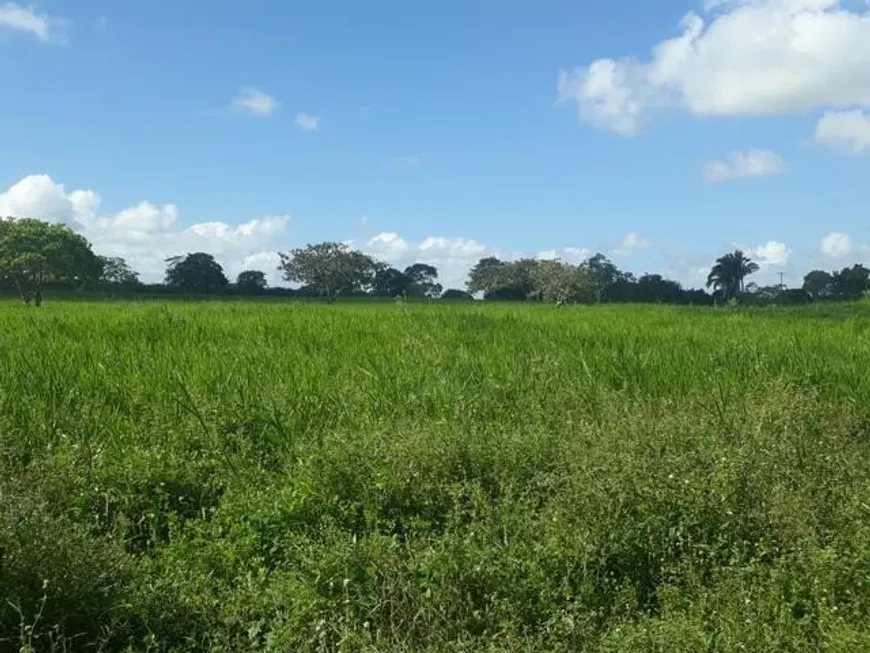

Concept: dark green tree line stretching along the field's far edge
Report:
left=0, top=218, right=870, bottom=305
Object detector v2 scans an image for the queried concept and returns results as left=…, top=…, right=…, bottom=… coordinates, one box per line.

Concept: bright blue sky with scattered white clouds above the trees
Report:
left=0, top=0, right=870, bottom=285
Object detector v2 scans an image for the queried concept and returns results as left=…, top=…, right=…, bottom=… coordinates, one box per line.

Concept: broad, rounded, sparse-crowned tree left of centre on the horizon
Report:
left=278, top=242, right=385, bottom=301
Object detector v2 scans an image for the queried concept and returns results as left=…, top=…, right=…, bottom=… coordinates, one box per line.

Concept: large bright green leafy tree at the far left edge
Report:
left=0, top=218, right=103, bottom=303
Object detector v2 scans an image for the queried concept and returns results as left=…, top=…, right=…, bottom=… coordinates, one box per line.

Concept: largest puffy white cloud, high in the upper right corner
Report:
left=558, top=0, right=870, bottom=136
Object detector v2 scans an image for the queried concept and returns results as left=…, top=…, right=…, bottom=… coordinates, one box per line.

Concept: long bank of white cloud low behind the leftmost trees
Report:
left=0, top=175, right=290, bottom=283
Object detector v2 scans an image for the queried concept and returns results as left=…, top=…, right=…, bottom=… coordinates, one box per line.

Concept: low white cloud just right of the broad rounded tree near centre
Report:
left=362, top=232, right=493, bottom=288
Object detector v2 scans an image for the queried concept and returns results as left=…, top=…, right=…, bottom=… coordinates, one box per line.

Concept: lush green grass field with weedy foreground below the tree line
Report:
left=0, top=301, right=870, bottom=653
